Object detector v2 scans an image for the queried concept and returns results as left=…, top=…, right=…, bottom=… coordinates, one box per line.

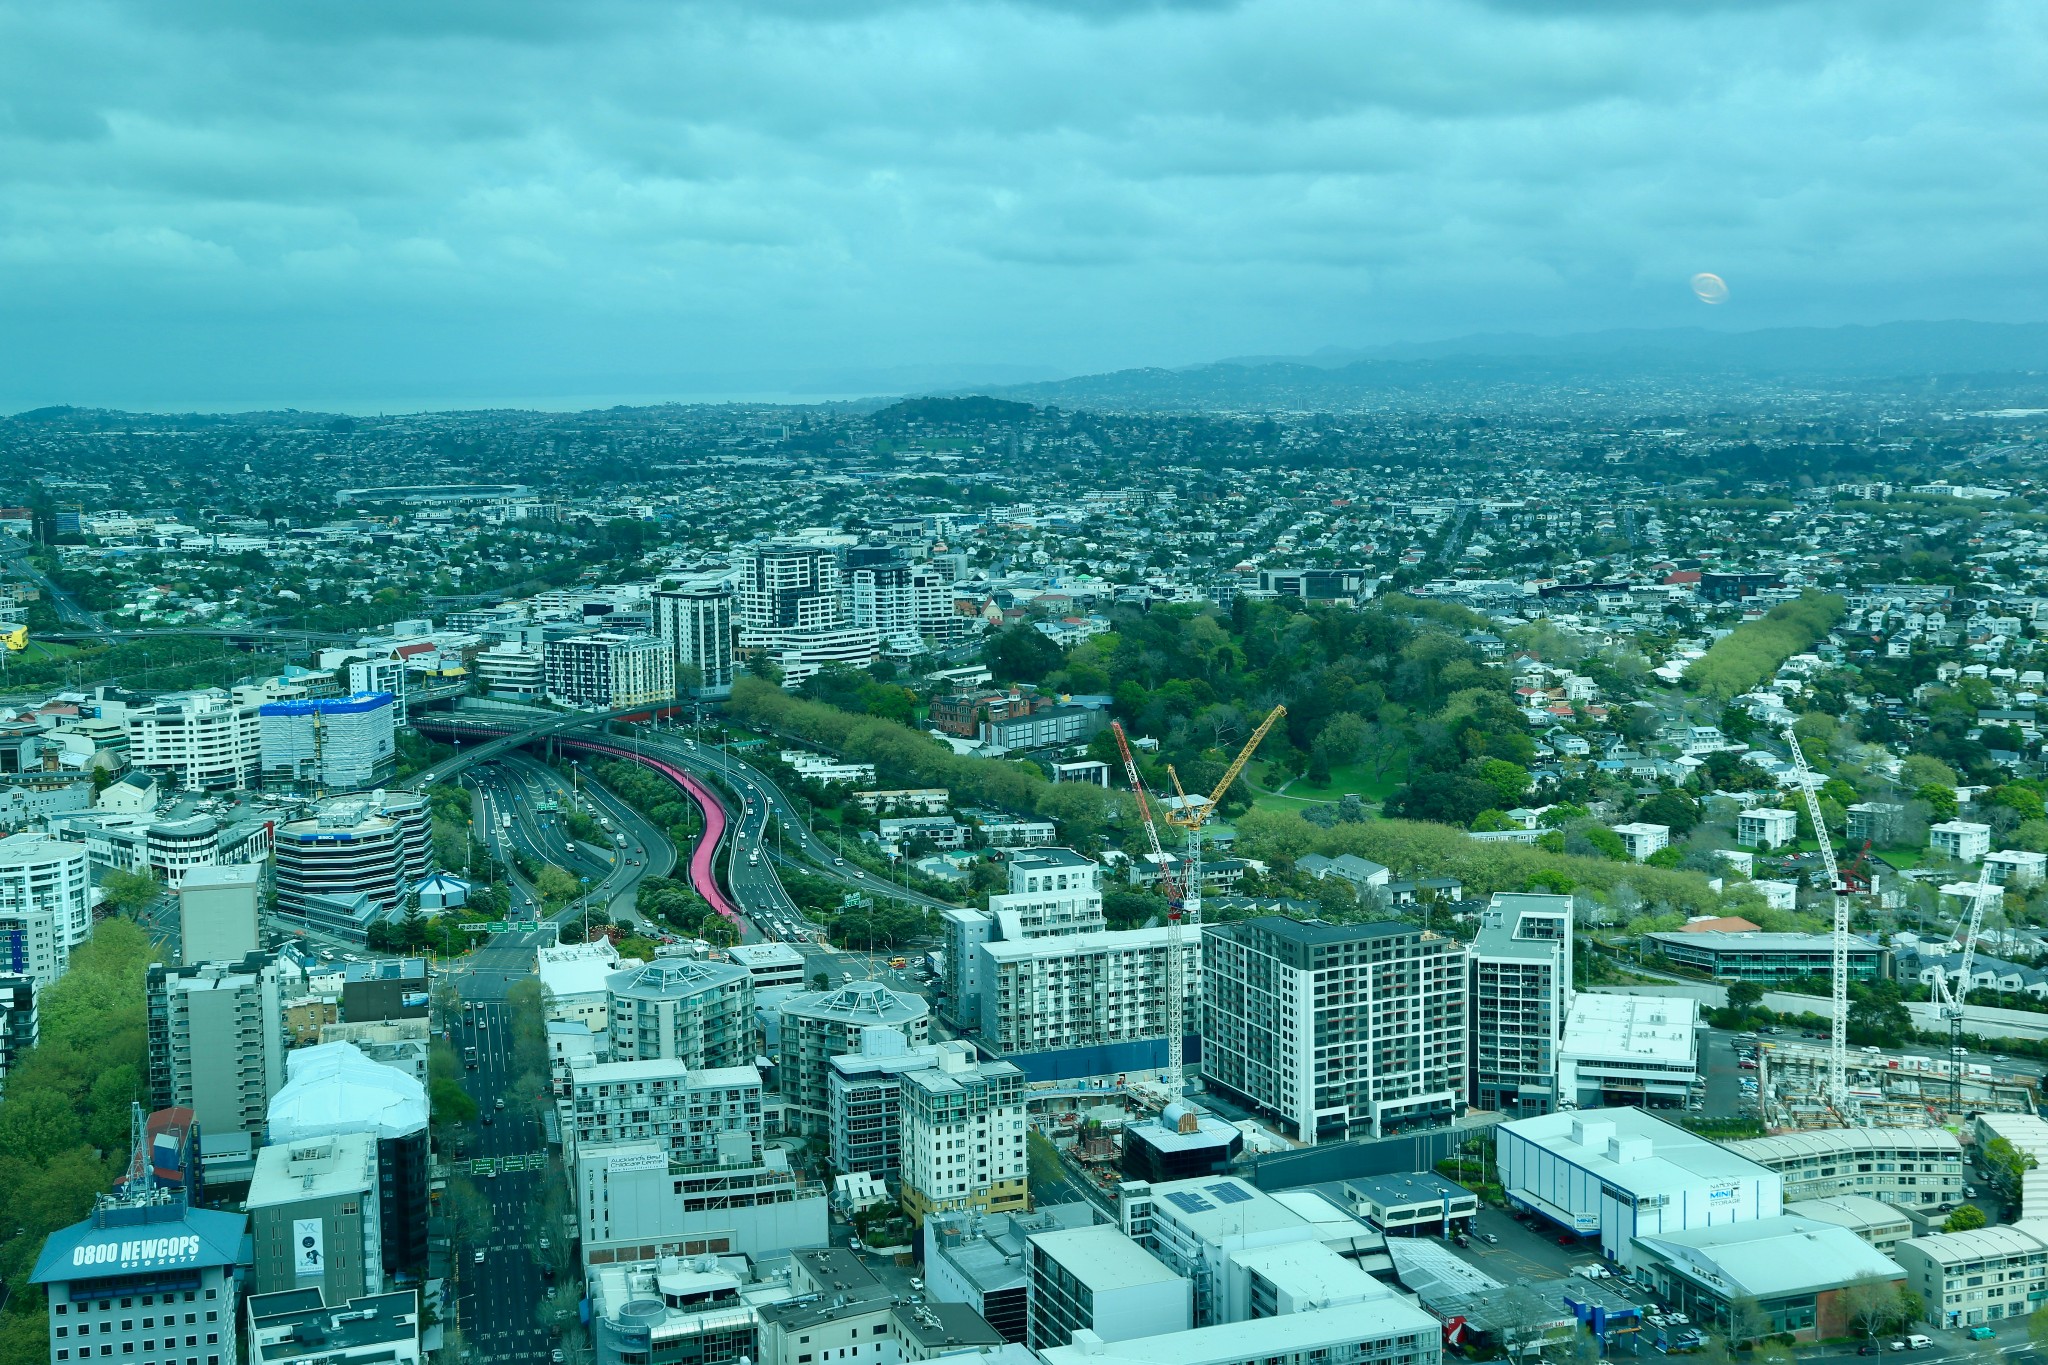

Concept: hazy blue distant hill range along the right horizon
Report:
left=966, top=321, right=2048, bottom=407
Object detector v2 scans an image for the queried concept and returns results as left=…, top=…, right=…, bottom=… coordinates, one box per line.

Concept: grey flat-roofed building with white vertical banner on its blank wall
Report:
left=246, top=1134, right=385, bottom=1304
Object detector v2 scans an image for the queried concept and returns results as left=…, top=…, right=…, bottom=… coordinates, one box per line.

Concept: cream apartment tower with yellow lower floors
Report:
left=901, top=1048, right=1030, bottom=1224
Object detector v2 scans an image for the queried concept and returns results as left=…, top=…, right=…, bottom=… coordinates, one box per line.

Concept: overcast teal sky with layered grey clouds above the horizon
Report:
left=0, top=0, right=2048, bottom=409
